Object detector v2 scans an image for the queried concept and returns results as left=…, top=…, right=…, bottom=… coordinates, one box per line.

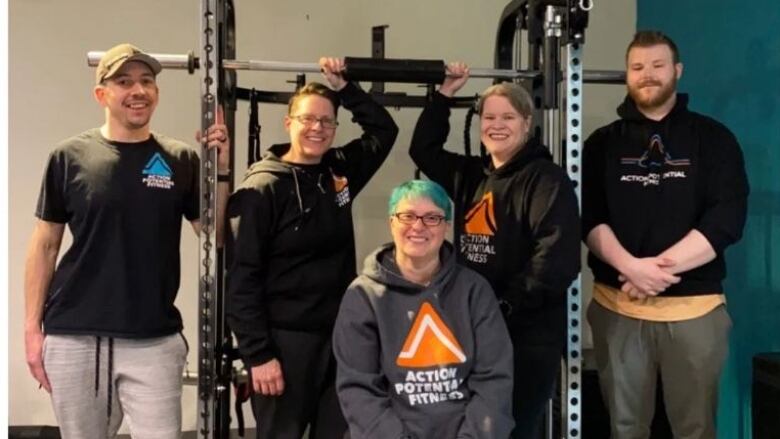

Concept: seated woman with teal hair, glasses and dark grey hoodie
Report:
left=333, top=180, right=513, bottom=439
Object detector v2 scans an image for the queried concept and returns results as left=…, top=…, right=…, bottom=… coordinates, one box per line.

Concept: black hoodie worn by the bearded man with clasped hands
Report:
left=582, top=94, right=749, bottom=296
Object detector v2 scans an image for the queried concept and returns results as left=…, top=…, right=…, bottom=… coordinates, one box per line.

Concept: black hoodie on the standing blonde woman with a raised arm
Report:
left=409, top=92, right=580, bottom=345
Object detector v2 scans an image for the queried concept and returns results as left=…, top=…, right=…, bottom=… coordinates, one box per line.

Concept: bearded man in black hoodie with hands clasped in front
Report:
left=582, top=31, right=748, bottom=438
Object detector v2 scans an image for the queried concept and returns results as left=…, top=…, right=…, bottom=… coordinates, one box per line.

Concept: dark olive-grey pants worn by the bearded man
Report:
left=586, top=301, right=731, bottom=439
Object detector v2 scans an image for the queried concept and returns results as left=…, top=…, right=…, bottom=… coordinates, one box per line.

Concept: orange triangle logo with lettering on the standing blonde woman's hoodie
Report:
left=460, top=192, right=498, bottom=264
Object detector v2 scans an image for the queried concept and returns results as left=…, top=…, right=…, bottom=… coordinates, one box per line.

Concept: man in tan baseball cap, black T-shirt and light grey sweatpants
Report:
left=24, top=44, right=230, bottom=438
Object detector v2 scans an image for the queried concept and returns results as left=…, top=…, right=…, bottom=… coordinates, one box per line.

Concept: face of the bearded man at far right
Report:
left=626, top=44, right=682, bottom=111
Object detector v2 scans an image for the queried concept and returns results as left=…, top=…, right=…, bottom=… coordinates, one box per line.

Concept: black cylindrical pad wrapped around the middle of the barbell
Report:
left=344, top=57, right=445, bottom=84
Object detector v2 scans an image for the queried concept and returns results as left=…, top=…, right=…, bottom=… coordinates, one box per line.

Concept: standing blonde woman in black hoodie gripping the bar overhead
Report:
left=409, top=63, right=580, bottom=438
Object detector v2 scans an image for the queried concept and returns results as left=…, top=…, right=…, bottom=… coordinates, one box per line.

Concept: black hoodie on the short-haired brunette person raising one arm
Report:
left=226, top=84, right=398, bottom=366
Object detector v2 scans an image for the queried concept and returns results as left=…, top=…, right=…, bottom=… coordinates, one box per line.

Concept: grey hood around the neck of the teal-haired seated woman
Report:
left=363, top=241, right=455, bottom=293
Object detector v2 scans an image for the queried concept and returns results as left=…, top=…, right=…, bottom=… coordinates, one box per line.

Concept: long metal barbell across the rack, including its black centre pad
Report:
left=87, top=52, right=625, bottom=84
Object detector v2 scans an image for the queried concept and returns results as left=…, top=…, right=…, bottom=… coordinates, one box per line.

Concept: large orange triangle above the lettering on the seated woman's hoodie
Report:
left=395, top=302, right=466, bottom=367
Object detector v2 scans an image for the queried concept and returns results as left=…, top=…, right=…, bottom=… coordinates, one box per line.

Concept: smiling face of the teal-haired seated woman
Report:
left=390, top=197, right=449, bottom=262
